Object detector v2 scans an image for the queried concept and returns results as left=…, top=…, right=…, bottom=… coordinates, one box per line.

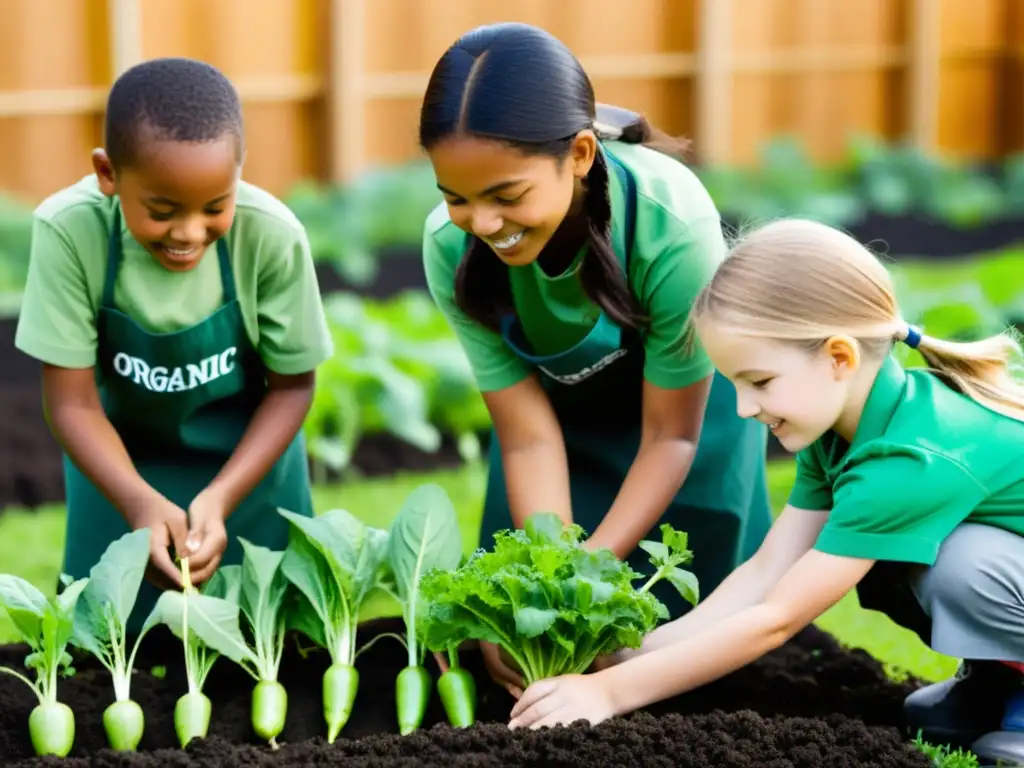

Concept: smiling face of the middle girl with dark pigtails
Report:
left=428, top=131, right=597, bottom=266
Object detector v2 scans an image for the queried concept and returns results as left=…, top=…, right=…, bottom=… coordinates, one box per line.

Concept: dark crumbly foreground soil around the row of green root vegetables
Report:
left=0, top=620, right=930, bottom=768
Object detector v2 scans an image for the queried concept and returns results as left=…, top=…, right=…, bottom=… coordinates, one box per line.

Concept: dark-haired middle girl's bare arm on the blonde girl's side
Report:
left=587, top=376, right=712, bottom=559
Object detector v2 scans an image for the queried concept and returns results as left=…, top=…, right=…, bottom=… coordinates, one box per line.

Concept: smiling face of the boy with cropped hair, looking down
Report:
left=93, top=134, right=242, bottom=271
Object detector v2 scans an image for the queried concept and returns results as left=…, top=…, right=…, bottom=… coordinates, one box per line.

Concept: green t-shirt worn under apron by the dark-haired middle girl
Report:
left=423, top=141, right=726, bottom=392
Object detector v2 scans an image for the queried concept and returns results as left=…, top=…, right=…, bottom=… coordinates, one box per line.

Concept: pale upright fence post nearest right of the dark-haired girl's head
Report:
left=694, top=0, right=733, bottom=163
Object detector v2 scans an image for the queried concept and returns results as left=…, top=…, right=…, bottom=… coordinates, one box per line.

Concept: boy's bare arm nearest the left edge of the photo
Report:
left=43, top=365, right=162, bottom=523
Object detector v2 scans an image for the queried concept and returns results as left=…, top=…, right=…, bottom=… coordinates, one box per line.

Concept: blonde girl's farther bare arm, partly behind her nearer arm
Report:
left=618, top=506, right=828, bottom=659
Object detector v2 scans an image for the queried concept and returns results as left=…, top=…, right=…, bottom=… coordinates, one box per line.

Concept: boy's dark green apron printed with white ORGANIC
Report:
left=63, top=208, right=313, bottom=632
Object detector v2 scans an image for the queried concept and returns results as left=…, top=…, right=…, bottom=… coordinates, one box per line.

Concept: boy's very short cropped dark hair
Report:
left=104, top=57, right=244, bottom=168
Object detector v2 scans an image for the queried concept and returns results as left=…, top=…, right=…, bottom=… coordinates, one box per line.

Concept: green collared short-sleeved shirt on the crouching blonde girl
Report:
left=790, top=356, right=1024, bottom=565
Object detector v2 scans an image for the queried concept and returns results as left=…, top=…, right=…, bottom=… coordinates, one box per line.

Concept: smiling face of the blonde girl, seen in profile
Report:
left=697, top=322, right=870, bottom=453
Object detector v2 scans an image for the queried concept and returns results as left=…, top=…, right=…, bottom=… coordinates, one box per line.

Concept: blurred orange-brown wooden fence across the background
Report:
left=0, top=0, right=1024, bottom=200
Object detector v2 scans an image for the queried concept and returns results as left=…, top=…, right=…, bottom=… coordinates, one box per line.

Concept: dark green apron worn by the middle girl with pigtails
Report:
left=480, top=154, right=772, bottom=617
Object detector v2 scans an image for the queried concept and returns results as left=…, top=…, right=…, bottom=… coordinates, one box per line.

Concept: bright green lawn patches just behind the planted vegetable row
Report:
left=0, top=461, right=956, bottom=680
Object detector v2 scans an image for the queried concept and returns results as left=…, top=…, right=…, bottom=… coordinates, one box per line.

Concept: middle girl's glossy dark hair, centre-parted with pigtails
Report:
left=420, top=23, right=685, bottom=330
